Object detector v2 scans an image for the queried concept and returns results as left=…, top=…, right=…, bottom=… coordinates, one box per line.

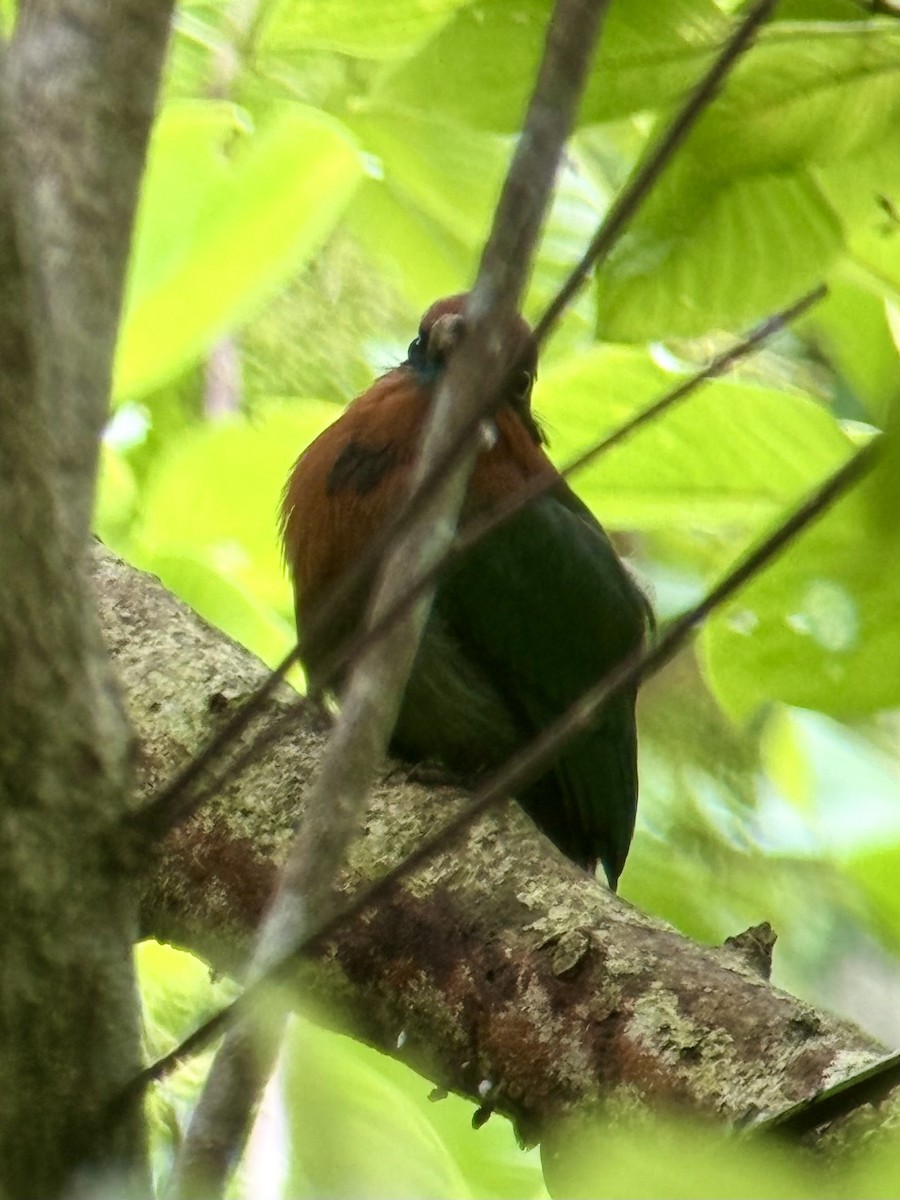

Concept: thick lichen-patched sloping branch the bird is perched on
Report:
left=95, top=547, right=897, bottom=1140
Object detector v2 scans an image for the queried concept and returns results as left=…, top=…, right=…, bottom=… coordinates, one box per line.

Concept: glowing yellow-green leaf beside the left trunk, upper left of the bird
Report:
left=115, top=102, right=362, bottom=400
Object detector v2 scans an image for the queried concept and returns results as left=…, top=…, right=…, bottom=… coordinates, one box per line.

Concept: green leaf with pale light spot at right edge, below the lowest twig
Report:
left=701, top=451, right=900, bottom=719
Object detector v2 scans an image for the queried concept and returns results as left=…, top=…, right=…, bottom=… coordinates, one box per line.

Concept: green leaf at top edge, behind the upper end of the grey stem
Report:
left=376, top=0, right=728, bottom=133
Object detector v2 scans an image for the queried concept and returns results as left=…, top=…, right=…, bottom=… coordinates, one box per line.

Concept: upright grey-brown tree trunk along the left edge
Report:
left=0, top=0, right=170, bottom=1200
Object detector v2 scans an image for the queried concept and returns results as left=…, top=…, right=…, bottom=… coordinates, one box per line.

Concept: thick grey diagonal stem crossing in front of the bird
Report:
left=169, top=0, right=619, bottom=1195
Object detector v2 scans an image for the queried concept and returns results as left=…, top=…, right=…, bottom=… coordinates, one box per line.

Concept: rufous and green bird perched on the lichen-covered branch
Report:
left=281, top=293, right=653, bottom=890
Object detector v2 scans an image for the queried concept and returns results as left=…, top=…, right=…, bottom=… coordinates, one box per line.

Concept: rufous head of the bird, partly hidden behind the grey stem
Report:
left=403, top=292, right=545, bottom=443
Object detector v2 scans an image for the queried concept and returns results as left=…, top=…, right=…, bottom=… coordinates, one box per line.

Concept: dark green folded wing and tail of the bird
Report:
left=436, top=488, right=649, bottom=887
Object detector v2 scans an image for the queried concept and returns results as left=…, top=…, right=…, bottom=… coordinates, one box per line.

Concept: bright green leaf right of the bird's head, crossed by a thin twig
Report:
left=534, top=347, right=850, bottom=530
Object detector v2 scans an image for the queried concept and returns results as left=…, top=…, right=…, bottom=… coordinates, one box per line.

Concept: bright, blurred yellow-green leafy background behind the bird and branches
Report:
left=102, top=0, right=900, bottom=1196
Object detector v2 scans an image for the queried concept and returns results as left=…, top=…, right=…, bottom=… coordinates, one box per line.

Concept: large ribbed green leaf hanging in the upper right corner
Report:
left=598, top=22, right=900, bottom=341
